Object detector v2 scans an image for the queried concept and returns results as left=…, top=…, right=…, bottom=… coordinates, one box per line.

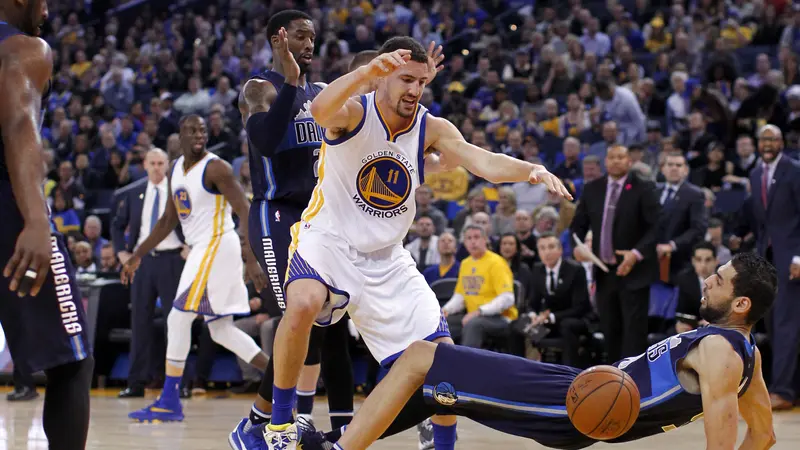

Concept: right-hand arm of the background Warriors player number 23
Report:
left=204, top=159, right=267, bottom=292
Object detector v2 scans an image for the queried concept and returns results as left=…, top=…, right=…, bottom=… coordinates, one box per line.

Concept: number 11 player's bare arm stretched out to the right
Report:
left=425, top=115, right=572, bottom=200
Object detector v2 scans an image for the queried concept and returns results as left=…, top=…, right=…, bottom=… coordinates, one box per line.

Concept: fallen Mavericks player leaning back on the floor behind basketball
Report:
left=303, top=253, right=777, bottom=450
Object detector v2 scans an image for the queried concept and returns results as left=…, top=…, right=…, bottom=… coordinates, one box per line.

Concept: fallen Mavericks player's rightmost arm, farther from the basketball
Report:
left=739, top=348, right=775, bottom=450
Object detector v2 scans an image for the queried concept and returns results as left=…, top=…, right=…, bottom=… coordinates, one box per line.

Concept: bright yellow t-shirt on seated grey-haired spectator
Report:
left=455, top=251, right=519, bottom=320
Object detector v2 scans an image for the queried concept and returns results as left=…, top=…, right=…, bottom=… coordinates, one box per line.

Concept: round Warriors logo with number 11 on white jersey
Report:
left=353, top=150, right=415, bottom=218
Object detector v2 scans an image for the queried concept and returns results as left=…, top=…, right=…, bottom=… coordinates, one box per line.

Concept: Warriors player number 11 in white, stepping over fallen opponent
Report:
left=265, top=37, right=571, bottom=450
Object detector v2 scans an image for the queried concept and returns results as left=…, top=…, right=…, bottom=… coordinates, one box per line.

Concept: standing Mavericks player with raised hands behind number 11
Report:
left=229, top=10, right=354, bottom=449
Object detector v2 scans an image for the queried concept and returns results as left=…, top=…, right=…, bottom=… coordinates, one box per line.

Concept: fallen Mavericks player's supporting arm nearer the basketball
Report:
left=691, top=336, right=744, bottom=450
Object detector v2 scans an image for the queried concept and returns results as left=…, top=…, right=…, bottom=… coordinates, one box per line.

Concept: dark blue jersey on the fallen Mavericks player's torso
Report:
left=611, top=326, right=756, bottom=442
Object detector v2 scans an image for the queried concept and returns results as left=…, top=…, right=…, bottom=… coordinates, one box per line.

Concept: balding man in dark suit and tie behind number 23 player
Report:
left=111, top=149, right=184, bottom=397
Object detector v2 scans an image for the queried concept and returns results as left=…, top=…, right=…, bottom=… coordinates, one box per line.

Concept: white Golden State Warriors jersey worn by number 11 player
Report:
left=302, top=92, right=427, bottom=253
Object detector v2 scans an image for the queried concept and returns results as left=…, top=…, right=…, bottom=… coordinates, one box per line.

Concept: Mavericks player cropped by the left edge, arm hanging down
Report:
left=0, top=0, right=94, bottom=450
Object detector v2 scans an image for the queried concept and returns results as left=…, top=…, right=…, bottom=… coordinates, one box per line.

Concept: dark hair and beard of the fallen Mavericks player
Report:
left=731, top=252, right=778, bottom=325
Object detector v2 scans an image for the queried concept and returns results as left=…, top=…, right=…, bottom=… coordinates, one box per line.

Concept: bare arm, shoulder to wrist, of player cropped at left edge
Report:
left=0, top=35, right=53, bottom=227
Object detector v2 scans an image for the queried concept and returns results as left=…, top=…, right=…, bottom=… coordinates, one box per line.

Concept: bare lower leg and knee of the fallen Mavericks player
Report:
left=337, top=341, right=440, bottom=450
